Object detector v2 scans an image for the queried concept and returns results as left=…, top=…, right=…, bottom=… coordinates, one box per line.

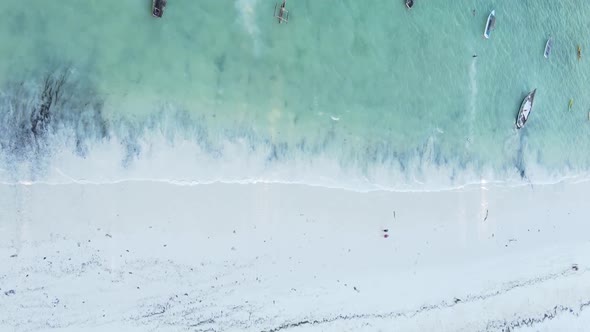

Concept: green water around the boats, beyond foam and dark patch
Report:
left=0, top=0, right=590, bottom=187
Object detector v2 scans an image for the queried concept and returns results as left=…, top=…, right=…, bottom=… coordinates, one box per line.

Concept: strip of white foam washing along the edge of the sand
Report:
left=0, top=128, right=589, bottom=192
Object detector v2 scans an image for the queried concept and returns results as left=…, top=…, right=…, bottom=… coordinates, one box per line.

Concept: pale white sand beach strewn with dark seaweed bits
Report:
left=0, top=182, right=590, bottom=331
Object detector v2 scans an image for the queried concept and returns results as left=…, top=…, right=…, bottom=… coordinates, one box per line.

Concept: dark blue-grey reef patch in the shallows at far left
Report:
left=0, top=68, right=109, bottom=176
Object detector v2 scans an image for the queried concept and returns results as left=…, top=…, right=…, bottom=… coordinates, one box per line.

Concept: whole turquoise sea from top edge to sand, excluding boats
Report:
left=0, top=0, right=590, bottom=189
